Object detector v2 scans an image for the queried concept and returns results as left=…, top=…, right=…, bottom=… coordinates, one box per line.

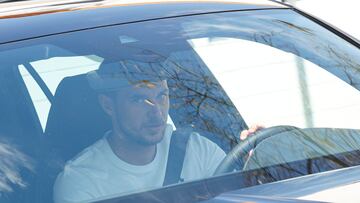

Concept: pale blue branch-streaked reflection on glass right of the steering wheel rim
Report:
left=244, top=128, right=360, bottom=185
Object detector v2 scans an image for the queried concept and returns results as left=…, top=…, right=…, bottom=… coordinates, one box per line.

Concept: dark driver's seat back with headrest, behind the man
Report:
left=42, top=74, right=111, bottom=202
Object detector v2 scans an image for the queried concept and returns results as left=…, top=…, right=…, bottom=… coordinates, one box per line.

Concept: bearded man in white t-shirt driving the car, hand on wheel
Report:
left=54, top=61, right=254, bottom=202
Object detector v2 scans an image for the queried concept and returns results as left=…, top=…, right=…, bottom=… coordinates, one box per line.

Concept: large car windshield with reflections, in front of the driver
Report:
left=0, top=9, right=360, bottom=202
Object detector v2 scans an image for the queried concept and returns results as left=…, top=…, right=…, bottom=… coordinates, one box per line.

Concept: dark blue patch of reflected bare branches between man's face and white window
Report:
left=112, top=42, right=244, bottom=149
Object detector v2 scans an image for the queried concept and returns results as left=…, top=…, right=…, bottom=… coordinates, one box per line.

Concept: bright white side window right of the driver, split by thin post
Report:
left=191, top=38, right=360, bottom=128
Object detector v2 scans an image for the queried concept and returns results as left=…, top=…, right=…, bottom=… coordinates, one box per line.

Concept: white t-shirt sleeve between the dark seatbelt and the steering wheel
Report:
left=187, top=133, right=226, bottom=178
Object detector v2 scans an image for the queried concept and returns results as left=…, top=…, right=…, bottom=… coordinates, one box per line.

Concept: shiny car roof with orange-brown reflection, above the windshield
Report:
left=0, top=0, right=287, bottom=44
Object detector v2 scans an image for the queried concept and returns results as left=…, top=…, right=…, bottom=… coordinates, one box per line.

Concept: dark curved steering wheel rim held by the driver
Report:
left=214, top=125, right=299, bottom=175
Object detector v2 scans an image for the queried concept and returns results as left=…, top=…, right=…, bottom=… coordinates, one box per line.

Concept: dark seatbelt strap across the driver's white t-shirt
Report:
left=163, top=129, right=191, bottom=186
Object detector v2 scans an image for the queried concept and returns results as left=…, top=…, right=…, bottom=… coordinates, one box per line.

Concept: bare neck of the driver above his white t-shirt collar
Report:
left=107, top=131, right=156, bottom=165
